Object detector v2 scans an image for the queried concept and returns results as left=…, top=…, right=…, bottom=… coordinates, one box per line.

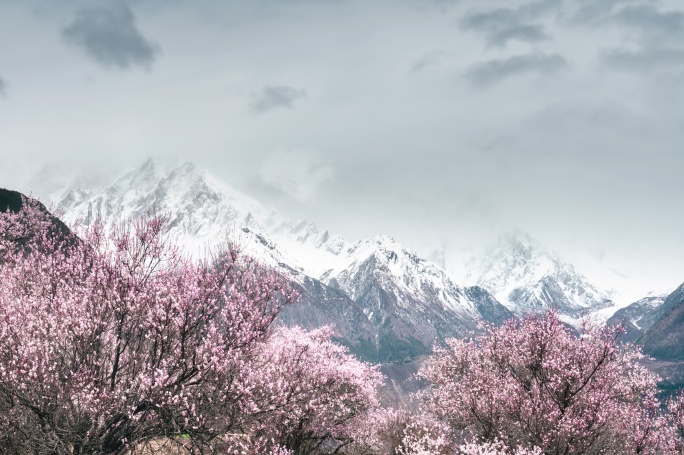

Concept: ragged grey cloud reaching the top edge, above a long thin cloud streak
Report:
left=460, top=0, right=560, bottom=47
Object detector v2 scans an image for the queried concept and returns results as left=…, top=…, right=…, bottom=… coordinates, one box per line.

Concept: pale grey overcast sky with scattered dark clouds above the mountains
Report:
left=0, top=0, right=684, bottom=298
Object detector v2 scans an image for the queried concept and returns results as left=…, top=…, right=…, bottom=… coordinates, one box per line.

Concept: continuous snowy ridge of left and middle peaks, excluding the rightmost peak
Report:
left=58, top=160, right=510, bottom=360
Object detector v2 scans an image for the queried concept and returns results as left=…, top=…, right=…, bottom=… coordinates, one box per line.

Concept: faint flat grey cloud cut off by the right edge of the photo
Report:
left=603, top=47, right=684, bottom=73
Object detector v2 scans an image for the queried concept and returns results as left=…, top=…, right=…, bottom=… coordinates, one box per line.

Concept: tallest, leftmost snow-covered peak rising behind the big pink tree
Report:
left=57, top=160, right=345, bottom=276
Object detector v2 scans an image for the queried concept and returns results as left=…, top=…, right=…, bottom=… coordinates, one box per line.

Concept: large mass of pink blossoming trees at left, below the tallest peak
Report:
left=0, top=200, right=379, bottom=454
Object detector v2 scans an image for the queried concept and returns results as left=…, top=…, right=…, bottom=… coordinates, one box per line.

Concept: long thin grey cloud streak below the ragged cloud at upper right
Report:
left=464, top=53, right=568, bottom=87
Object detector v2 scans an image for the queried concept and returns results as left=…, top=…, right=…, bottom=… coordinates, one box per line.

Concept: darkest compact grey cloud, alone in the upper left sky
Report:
left=62, top=2, right=160, bottom=70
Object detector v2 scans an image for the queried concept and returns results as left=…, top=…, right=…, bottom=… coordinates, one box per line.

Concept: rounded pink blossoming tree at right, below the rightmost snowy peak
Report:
left=421, top=312, right=681, bottom=454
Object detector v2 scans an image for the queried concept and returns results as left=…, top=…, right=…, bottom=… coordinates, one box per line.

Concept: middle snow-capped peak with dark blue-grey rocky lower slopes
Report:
left=321, top=236, right=512, bottom=358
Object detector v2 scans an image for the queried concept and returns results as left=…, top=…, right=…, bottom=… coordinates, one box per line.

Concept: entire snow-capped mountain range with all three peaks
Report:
left=49, top=160, right=680, bottom=361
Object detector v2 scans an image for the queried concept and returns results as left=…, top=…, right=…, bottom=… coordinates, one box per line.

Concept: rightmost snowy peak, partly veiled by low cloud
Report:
left=448, top=231, right=617, bottom=323
